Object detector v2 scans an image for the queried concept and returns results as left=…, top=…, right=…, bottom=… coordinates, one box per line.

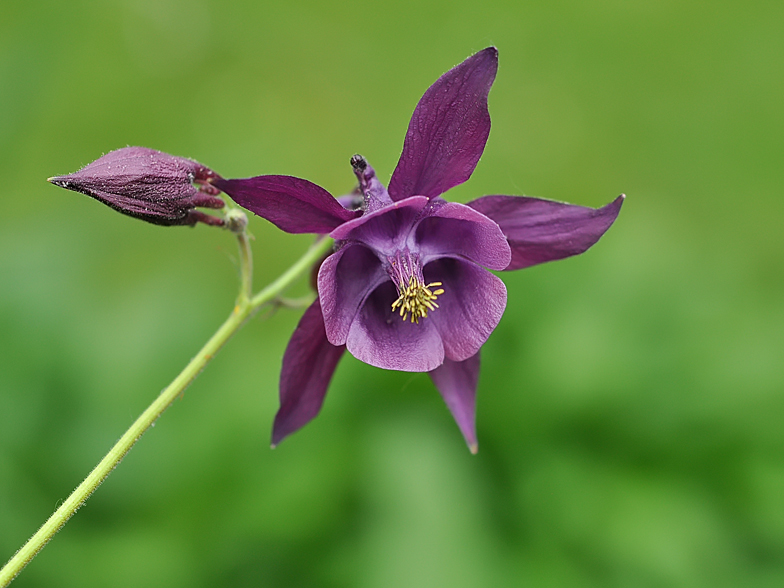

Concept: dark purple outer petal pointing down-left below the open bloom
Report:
left=272, top=299, right=346, bottom=447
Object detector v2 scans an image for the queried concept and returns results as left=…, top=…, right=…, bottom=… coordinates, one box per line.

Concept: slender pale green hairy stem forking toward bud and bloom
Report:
left=0, top=231, right=332, bottom=588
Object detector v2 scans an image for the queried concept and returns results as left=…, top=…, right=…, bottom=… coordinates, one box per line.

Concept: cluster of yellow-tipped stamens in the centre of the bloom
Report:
left=387, top=251, right=444, bottom=323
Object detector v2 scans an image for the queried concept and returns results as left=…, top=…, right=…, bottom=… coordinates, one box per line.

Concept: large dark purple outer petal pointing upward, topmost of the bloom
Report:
left=389, top=47, right=498, bottom=200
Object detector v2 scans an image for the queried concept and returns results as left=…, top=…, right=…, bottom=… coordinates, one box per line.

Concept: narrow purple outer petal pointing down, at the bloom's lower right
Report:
left=430, top=353, right=479, bottom=453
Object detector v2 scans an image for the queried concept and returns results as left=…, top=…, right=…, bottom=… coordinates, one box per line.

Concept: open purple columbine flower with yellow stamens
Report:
left=213, top=47, right=623, bottom=452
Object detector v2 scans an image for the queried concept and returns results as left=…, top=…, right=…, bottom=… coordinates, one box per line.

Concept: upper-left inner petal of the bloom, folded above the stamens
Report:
left=329, top=196, right=428, bottom=255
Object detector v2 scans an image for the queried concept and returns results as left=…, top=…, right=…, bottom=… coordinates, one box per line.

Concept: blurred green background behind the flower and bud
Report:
left=0, top=0, right=784, bottom=588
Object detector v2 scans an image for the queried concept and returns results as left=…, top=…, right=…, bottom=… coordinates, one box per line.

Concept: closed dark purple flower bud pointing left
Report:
left=49, top=147, right=224, bottom=226
